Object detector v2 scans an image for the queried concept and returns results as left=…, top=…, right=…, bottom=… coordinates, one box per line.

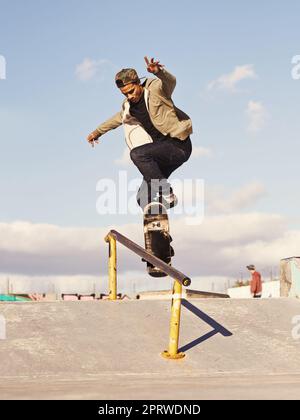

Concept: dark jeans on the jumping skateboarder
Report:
left=130, top=137, right=192, bottom=208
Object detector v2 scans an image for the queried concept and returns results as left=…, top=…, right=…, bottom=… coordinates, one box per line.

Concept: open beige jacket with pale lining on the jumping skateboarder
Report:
left=97, top=69, right=193, bottom=149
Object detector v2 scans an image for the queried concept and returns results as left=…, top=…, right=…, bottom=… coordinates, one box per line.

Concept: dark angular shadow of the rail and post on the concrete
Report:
left=178, top=299, right=233, bottom=353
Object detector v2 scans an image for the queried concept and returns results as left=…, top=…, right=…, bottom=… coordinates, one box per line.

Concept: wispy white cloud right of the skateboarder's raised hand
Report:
left=208, top=64, right=257, bottom=92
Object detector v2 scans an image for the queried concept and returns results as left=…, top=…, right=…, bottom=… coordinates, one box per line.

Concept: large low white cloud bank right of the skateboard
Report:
left=171, top=213, right=290, bottom=276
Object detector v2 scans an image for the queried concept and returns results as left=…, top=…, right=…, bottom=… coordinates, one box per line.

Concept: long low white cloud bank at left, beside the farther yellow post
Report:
left=0, top=221, right=143, bottom=275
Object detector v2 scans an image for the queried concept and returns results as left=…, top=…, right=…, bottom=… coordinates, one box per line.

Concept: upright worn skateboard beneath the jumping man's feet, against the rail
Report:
left=144, top=202, right=174, bottom=277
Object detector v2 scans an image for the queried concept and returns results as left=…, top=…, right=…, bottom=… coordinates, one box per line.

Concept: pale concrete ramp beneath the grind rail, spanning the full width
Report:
left=0, top=299, right=300, bottom=400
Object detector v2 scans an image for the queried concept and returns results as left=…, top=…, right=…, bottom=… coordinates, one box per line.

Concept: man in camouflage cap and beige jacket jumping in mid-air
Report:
left=87, top=57, right=192, bottom=209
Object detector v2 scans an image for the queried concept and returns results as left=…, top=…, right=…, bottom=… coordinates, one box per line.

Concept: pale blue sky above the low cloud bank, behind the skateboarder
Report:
left=0, top=0, right=300, bottom=286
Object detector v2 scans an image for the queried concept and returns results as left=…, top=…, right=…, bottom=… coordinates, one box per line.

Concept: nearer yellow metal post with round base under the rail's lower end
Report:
left=161, top=280, right=185, bottom=359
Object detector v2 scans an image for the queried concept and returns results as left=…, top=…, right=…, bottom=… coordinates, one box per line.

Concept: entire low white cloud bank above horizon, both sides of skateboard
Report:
left=0, top=208, right=300, bottom=282
